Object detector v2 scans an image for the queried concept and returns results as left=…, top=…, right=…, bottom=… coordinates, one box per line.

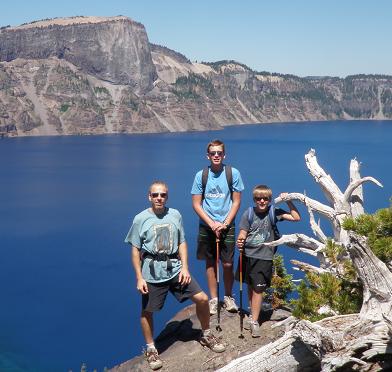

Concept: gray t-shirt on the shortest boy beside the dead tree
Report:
left=240, top=208, right=287, bottom=261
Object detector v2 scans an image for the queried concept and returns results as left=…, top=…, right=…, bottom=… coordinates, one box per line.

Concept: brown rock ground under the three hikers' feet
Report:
left=110, top=305, right=290, bottom=372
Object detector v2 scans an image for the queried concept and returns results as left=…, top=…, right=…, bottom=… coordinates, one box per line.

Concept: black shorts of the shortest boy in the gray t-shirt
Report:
left=235, top=255, right=273, bottom=293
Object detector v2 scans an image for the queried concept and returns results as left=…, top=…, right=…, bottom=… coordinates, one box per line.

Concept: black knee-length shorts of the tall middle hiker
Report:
left=197, top=225, right=235, bottom=263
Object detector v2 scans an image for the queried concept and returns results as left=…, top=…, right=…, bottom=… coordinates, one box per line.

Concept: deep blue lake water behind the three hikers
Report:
left=0, top=121, right=392, bottom=372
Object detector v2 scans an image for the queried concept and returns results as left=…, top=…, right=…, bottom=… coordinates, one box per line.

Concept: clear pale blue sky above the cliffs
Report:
left=0, top=0, right=392, bottom=77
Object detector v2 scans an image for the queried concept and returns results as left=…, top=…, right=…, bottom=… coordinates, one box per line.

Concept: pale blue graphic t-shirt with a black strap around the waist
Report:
left=125, top=208, right=185, bottom=283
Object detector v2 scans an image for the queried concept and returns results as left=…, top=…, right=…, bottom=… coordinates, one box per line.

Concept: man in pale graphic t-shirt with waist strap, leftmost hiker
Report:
left=125, top=181, right=225, bottom=370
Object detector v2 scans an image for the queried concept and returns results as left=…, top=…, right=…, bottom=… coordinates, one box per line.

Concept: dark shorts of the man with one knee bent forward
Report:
left=142, top=275, right=202, bottom=312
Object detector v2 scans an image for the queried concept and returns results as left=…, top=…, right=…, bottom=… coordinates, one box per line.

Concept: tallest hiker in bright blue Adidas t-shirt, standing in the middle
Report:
left=191, top=140, right=244, bottom=315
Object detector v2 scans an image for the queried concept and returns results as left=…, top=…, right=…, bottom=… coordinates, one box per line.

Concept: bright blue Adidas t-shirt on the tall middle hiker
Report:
left=191, top=167, right=244, bottom=225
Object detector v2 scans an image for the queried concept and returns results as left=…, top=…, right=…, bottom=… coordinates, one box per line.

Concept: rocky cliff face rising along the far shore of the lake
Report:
left=0, top=17, right=392, bottom=136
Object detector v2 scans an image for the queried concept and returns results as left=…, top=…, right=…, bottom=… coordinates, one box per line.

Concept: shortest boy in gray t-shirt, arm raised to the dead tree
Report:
left=236, top=185, right=301, bottom=337
